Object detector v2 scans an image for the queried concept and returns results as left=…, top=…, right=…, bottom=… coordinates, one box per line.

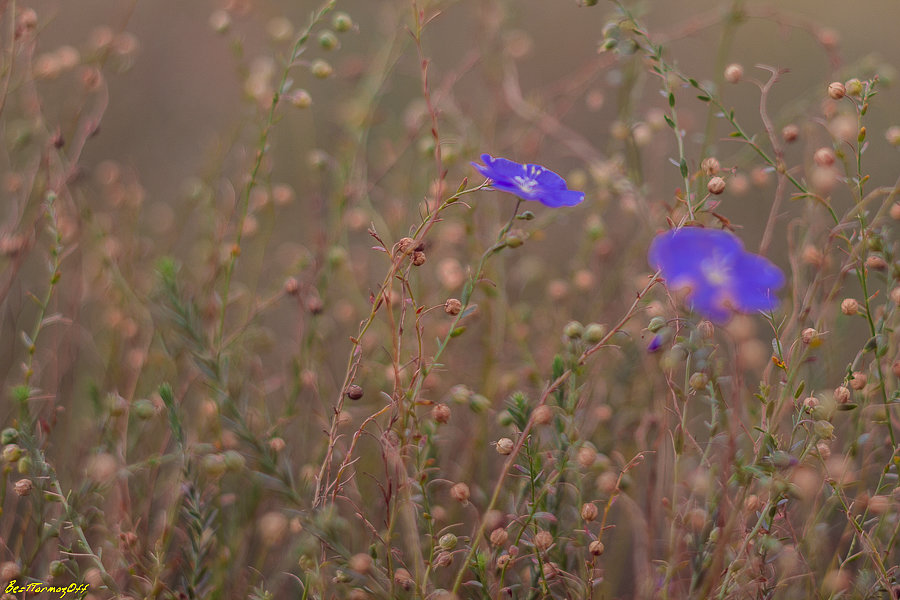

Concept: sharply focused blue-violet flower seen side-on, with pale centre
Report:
left=472, top=154, right=584, bottom=207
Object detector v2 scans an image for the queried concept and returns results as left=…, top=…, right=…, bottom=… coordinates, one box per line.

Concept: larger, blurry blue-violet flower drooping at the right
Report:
left=648, top=227, right=784, bottom=323
